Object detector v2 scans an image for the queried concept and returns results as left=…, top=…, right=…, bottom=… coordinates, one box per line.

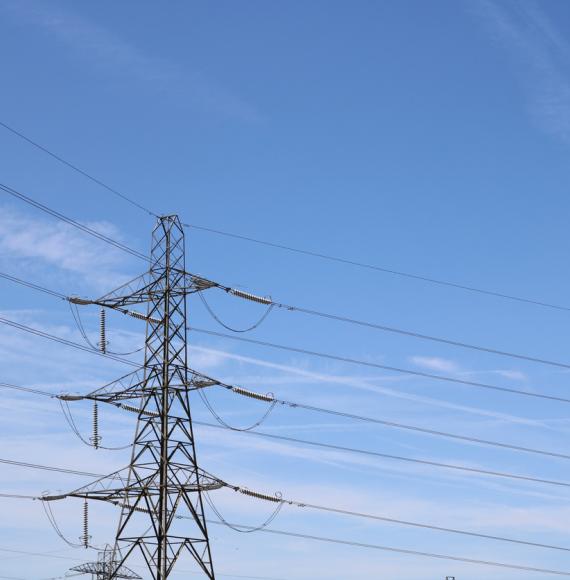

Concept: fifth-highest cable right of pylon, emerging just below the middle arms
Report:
left=194, top=421, right=570, bottom=488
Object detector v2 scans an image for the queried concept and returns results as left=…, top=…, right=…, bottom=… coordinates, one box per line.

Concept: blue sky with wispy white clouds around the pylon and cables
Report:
left=0, top=0, right=570, bottom=580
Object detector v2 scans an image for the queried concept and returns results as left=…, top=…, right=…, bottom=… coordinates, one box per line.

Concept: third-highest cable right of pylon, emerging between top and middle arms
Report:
left=187, top=326, right=570, bottom=403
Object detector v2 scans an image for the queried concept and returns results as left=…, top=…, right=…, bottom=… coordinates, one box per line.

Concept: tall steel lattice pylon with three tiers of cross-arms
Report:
left=62, top=216, right=222, bottom=580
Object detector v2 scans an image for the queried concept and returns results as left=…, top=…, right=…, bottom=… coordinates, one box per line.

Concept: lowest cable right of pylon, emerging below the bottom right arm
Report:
left=207, top=520, right=570, bottom=576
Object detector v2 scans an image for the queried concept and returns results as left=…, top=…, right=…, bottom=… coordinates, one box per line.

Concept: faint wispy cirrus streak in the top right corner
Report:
left=471, top=0, right=570, bottom=143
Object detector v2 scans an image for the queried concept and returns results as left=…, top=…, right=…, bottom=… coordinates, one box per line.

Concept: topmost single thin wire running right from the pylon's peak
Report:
left=182, top=223, right=570, bottom=312
